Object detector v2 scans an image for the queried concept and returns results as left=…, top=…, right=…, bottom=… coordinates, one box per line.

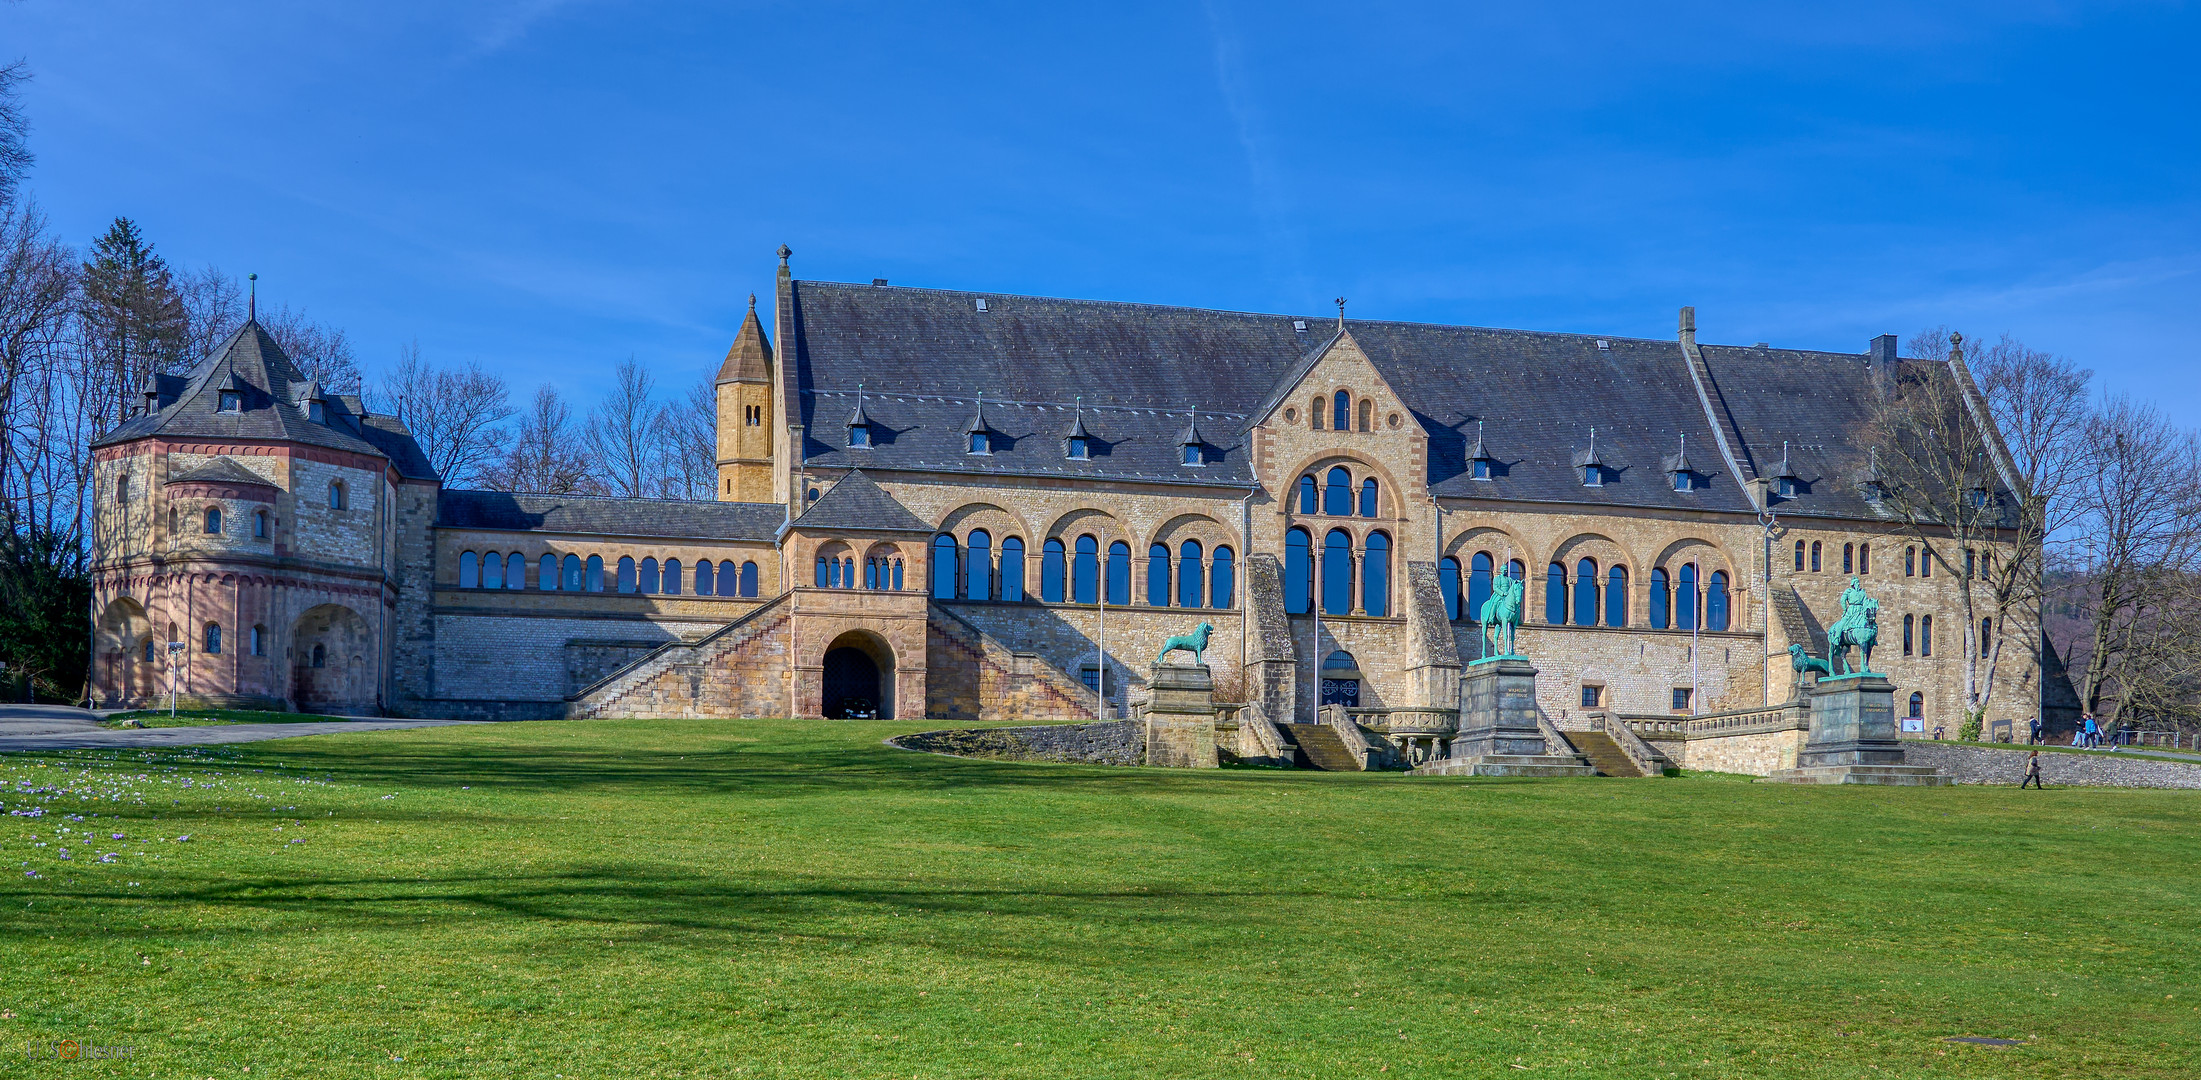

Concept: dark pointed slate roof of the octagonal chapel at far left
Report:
left=92, top=321, right=436, bottom=480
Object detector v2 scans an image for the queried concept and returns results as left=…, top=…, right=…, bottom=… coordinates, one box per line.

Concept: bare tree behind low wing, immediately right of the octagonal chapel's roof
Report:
left=368, top=341, right=513, bottom=488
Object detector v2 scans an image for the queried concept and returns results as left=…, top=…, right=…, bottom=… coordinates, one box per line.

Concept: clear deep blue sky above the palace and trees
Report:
left=0, top=0, right=2201, bottom=425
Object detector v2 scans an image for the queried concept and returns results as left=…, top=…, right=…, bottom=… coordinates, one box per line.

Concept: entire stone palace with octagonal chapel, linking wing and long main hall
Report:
left=92, top=249, right=2040, bottom=747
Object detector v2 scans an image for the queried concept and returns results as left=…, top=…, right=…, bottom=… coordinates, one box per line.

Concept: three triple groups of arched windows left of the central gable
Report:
left=933, top=528, right=1237, bottom=607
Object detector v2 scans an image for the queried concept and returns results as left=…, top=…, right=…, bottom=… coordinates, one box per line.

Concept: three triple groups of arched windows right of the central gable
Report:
left=1437, top=552, right=1732, bottom=631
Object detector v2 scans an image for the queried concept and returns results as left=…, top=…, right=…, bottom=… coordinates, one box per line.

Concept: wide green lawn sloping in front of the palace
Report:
left=0, top=721, right=2201, bottom=1080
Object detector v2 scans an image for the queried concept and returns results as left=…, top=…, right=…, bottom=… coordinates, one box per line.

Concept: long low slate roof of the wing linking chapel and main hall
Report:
left=436, top=488, right=787, bottom=541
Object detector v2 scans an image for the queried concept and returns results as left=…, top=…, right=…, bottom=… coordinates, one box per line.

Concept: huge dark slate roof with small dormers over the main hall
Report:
left=781, top=282, right=1939, bottom=519
